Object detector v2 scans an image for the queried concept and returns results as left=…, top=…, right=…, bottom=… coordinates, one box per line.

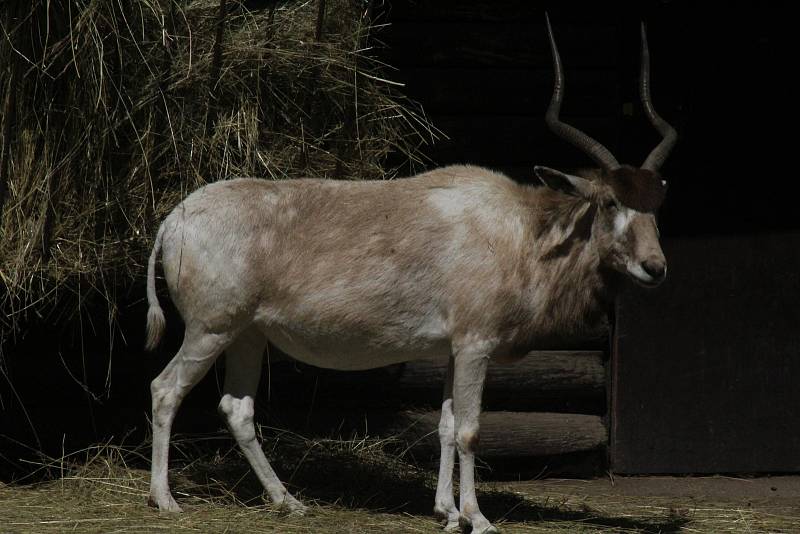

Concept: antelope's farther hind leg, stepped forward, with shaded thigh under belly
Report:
left=219, top=328, right=306, bottom=513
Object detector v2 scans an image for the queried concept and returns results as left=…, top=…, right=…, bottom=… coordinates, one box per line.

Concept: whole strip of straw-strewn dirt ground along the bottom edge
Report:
left=0, top=468, right=800, bottom=534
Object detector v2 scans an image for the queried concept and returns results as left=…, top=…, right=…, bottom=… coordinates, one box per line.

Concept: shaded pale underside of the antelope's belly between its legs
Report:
left=265, top=327, right=450, bottom=371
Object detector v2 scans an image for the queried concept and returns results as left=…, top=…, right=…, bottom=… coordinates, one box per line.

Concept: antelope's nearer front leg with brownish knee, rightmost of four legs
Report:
left=453, top=342, right=498, bottom=534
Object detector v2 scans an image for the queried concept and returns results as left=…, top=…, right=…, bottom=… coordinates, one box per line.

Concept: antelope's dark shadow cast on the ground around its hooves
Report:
left=181, top=440, right=689, bottom=533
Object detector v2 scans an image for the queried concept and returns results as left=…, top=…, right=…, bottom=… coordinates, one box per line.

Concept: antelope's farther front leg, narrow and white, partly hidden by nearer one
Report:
left=433, top=356, right=459, bottom=531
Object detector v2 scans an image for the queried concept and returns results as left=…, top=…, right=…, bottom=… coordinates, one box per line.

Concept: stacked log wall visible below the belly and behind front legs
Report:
left=265, top=350, right=608, bottom=466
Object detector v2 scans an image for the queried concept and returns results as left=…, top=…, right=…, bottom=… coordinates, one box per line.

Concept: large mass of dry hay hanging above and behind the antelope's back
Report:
left=0, top=0, right=434, bottom=340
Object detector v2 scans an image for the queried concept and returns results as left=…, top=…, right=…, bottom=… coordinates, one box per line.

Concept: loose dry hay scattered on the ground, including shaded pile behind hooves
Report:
left=0, top=436, right=797, bottom=533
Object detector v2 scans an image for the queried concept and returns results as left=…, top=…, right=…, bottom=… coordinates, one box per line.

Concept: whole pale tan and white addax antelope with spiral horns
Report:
left=147, top=15, right=676, bottom=534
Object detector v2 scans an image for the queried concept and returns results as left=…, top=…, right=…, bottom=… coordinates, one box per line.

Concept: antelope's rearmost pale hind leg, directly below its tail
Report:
left=148, top=328, right=233, bottom=512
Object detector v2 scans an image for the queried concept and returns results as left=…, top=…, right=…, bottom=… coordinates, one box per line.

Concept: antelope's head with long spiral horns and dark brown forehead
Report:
left=535, top=18, right=677, bottom=287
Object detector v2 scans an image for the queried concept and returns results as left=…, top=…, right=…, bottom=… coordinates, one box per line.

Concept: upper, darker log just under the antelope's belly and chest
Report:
left=261, top=351, right=606, bottom=414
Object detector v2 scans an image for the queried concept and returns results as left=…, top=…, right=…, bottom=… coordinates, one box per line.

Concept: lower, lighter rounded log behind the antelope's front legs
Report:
left=400, top=412, right=608, bottom=458
